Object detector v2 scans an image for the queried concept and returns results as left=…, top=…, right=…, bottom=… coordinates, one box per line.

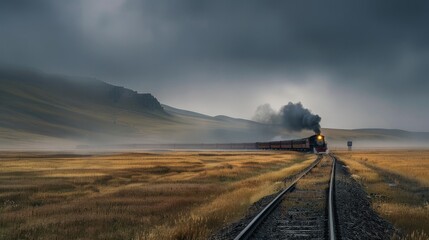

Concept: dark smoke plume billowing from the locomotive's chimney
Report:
left=253, top=102, right=322, bottom=134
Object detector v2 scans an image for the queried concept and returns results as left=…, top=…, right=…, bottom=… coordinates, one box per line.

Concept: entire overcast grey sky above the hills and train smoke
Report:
left=0, top=0, right=429, bottom=131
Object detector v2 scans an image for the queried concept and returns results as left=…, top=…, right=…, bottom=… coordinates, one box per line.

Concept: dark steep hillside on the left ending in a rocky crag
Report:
left=0, top=69, right=170, bottom=146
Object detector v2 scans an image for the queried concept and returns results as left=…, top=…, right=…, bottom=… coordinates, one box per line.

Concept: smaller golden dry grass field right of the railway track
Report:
left=336, top=150, right=429, bottom=239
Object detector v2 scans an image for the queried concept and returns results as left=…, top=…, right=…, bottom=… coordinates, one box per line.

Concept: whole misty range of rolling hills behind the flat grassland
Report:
left=0, top=69, right=429, bottom=149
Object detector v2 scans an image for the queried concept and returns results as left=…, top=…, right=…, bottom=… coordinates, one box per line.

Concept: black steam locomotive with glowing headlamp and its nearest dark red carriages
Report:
left=256, top=134, right=328, bottom=153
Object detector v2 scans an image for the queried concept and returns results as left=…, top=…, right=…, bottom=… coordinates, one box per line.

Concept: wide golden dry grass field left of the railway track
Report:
left=0, top=152, right=315, bottom=239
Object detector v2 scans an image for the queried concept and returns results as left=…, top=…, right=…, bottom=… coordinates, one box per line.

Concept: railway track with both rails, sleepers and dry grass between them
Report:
left=234, top=155, right=336, bottom=240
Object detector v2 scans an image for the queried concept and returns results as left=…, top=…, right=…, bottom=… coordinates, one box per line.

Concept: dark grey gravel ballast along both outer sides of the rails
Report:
left=210, top=155, right=395, bottom=240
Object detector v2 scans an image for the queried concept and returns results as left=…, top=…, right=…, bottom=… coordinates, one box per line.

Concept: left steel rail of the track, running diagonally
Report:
left=234, top=156, right=322, bottom=240
